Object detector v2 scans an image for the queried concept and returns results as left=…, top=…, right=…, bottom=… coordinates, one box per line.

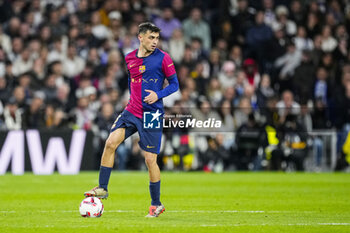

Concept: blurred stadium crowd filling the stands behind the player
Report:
left=0, top=0, right=350, bottom=171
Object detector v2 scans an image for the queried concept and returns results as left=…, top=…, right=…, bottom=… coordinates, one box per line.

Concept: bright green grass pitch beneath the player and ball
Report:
left=0, top=172, right=350, bottom=233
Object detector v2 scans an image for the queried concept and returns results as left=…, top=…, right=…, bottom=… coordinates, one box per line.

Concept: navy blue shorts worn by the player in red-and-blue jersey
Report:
left=110, top=110, right=162, bottom=154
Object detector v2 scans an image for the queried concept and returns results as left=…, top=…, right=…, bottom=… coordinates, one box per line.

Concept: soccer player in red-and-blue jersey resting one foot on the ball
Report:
left=84, top=22, right=179, bottom=217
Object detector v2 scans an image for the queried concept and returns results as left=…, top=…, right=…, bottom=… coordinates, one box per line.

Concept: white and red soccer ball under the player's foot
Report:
left=79, top=197, right=103, bottom=218
